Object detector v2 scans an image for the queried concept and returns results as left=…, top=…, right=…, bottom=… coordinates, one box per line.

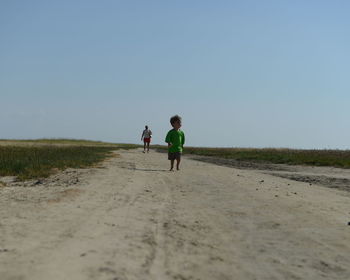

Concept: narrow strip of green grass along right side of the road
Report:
left=157, top=146, right=350, bottom=168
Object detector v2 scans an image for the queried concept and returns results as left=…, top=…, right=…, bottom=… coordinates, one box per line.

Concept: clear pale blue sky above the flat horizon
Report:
left=0, top=0, right=350, bottom=149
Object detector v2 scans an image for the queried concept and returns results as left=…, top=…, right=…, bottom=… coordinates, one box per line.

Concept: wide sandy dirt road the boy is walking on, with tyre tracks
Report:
left=0, top=150, right=350, bottom=280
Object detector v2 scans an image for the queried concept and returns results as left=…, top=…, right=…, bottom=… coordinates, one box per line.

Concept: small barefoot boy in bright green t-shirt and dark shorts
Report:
left=165, top=115, right=185, bottom=171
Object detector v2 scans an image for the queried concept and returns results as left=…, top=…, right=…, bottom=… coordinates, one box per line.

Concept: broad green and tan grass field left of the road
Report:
left=0, top=139, right=139, bottom=180
